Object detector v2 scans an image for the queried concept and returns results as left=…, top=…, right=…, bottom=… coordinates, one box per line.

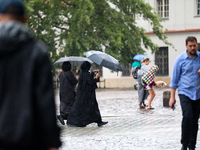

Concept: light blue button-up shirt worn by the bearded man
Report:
left=170, top=51, right=200, bottom=100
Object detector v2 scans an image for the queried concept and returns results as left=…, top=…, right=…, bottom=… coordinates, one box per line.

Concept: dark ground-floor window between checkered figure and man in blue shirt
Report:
left=155, top=47, right=169, bottom=76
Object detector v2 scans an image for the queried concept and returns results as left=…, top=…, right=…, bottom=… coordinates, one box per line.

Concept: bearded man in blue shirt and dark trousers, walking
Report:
left=169, top=36, right=200, bottom=150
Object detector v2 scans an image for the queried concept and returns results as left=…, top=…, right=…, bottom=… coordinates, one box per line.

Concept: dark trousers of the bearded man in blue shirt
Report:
left=179, top=94, right=200, bottom=148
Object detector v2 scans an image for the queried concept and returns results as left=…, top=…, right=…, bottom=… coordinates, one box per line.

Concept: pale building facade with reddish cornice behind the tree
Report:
left=101, top=0, right=200, bottom=88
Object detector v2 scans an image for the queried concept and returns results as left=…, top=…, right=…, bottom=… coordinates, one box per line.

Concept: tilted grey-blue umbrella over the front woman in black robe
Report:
left=84, top=50, right=122, bottom=71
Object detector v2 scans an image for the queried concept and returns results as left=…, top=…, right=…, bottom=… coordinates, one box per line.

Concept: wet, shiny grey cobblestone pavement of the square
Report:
left=56, top=88, right=200, bottom=150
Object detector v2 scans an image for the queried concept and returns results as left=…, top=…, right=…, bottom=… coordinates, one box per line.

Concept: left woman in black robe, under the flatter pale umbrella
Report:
left=57, top=61, right=78, bottom=125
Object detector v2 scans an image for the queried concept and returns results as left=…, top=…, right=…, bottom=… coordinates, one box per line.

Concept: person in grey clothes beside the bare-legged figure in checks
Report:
left=138, top=58, right=150, bottom=108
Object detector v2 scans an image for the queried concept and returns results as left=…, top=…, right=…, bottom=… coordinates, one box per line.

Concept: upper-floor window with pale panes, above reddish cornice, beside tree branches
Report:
left=157, top=0, right=169, bottom=18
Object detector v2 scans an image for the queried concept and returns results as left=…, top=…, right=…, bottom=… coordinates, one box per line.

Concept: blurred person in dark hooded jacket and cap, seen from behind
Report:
left=0, top=0, right=61, bottom=150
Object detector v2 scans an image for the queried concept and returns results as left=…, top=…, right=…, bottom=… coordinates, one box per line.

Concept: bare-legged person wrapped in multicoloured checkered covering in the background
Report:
left=141, top=65, right=159, bottom=109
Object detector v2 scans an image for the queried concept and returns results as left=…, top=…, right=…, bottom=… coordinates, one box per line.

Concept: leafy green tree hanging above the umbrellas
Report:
left=25, top=0, right=172, bottom=64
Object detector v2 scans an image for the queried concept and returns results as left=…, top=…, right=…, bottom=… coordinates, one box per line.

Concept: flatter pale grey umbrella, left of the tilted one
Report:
left=53, top=56, right=93, bottom=66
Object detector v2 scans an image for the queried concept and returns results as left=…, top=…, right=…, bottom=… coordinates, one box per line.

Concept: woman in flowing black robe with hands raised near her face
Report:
left=67, top=61, right=108, bottom=127
